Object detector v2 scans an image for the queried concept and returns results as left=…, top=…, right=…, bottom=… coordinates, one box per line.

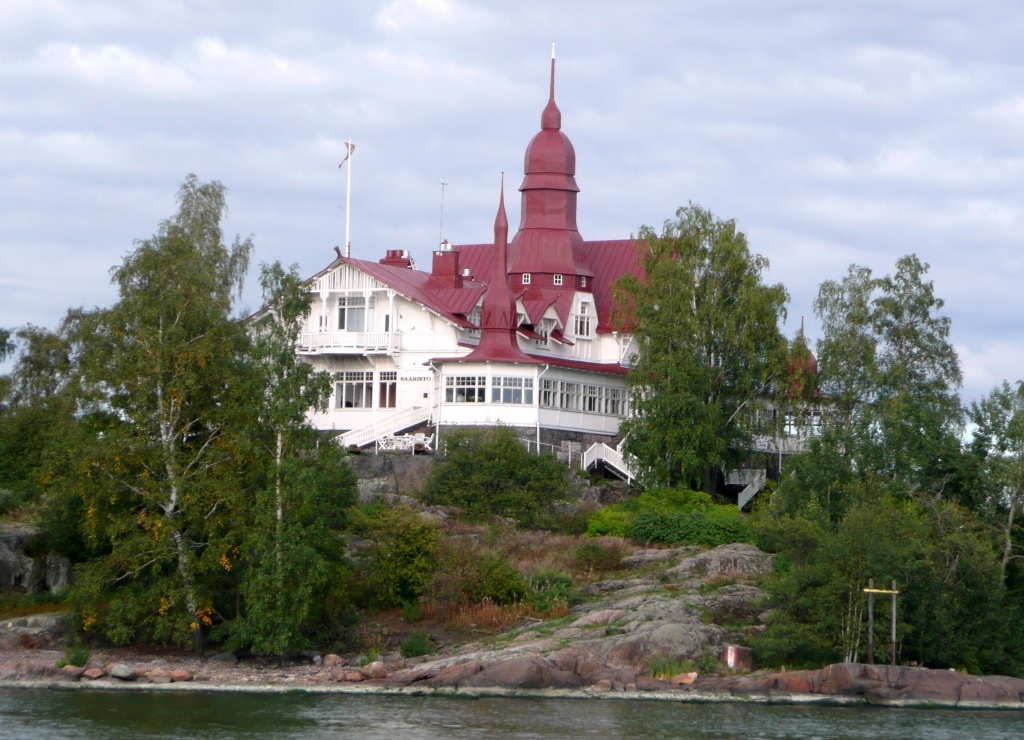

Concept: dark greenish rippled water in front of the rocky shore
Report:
left=0, top=689, right=1024, bottom=740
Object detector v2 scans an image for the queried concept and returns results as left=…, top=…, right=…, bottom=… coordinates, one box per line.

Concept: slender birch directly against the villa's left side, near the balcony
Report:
left=233, top=263, right=355, bottom=659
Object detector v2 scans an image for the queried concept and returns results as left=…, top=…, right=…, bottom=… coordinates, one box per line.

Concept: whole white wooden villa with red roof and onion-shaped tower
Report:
left=298, top=59, right=640, bottom=474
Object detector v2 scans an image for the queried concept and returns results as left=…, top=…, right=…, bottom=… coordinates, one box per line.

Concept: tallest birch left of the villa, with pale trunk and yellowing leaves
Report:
left=71, top=175, right=252, bottom=649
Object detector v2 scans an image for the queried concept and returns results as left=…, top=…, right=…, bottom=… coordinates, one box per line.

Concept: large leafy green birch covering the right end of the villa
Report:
left=614, top=204, right=787, bottom=490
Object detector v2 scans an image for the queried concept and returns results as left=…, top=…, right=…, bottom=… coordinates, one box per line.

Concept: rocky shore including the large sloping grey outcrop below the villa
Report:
left=6, top=545, right=1024, bottom=709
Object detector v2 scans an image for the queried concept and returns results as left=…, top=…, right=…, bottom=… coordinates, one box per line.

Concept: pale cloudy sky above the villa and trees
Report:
left=0, top=0, right=1024, bottom=400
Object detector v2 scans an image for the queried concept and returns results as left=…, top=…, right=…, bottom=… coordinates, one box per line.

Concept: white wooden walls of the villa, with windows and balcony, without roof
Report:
left=298, top=260, right=629, bottom=445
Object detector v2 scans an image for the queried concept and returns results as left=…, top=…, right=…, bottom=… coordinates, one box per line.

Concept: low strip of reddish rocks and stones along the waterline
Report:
left=0, top=651, right=1024, bottom=710
